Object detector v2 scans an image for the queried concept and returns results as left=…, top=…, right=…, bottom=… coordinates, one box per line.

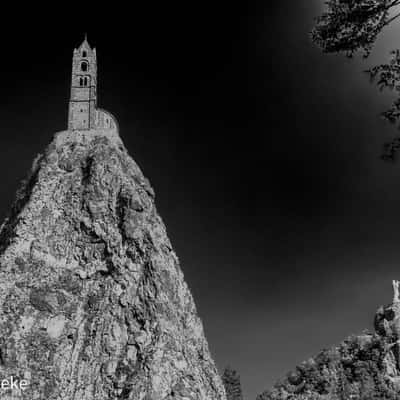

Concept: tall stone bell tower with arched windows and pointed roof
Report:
left=68, top=35, right=97, bottom=130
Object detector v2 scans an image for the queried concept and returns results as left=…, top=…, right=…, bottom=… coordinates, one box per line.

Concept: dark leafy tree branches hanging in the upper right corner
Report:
left=311, top=0, right=400, bottom=159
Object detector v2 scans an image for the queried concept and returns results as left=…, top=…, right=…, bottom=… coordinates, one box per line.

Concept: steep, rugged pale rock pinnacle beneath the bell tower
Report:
left=0, top=132, right=225, bottom=400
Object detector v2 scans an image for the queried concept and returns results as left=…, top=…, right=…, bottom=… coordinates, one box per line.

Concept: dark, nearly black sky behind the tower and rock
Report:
left=0, top=0, right=400, bottom=399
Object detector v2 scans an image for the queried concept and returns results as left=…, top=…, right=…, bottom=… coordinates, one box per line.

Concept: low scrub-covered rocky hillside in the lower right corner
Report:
left=257, top=301, right=400, bottom=400
